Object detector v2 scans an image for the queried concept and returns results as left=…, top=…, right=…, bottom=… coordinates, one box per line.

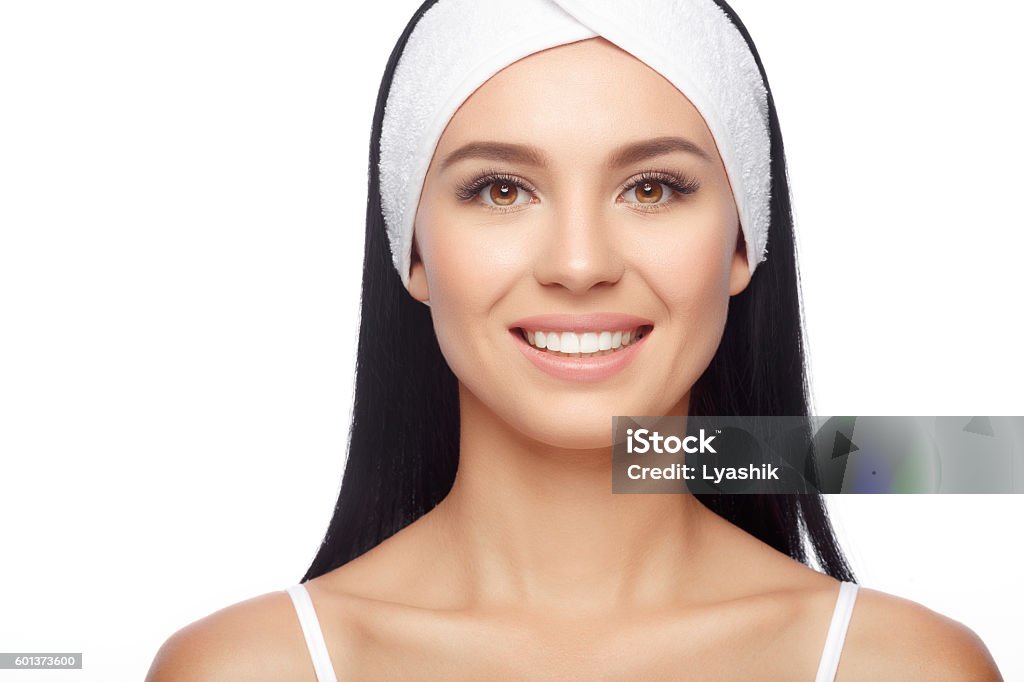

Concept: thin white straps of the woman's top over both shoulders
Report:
left=286, top=583, right=857, bottom=682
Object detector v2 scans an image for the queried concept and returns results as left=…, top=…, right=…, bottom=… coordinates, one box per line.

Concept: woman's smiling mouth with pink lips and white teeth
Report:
left=509, top=312, right=654, bottom=382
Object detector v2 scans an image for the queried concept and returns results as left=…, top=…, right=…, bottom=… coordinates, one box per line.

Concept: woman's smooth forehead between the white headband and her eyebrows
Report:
left=437, top=38, right=715, bottom=157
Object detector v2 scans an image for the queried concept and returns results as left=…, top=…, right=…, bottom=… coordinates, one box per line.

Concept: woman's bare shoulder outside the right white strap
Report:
left=837, top=588, right=1002, bottom=682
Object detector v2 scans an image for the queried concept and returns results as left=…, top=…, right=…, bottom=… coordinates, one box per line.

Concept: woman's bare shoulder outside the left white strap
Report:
left=145, top=591, right=315, bottom=682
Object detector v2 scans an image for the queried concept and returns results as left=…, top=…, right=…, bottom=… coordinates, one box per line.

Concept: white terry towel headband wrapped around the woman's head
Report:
left=380, top=0, right=771, bottom=303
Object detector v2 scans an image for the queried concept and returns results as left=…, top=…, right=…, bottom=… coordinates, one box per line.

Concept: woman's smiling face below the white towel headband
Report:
left=410, top=38, right=750, bottom=447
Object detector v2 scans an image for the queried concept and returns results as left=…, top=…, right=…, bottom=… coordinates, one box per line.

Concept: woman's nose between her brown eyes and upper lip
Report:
left=534, top=203, right=625, bottom=295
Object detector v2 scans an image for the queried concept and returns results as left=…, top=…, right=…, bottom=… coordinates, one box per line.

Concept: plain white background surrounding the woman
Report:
left=0, top=0, right=1024, bottom=680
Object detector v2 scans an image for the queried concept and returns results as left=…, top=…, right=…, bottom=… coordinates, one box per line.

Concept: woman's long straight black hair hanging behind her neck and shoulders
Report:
left=302, top=0, right=854, bottom=582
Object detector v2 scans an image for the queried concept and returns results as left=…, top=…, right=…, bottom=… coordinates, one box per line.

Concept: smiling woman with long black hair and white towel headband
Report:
left=148, top=0, right=1000, bottom=682
